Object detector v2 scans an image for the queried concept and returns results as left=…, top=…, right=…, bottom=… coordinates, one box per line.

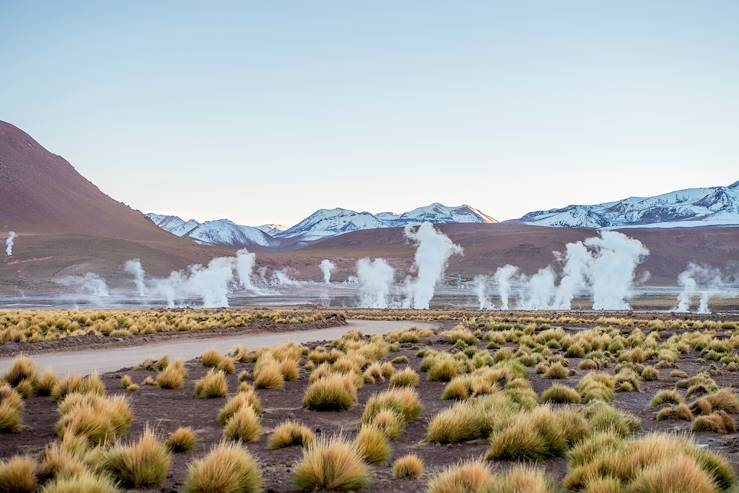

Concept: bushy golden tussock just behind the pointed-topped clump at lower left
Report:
left=56, top=393, right=133, bottom=445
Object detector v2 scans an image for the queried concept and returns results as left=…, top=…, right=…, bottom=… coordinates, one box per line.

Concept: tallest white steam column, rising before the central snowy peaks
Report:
left=403, top=223, right=463, bottom=310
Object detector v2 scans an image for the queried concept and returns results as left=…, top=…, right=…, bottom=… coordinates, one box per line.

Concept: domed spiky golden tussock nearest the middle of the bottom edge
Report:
left=294, top=438, right=370, bottom=491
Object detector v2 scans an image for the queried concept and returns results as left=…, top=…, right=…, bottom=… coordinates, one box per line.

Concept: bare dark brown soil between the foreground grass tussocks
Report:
left=0, top=321, right=739, bottom=493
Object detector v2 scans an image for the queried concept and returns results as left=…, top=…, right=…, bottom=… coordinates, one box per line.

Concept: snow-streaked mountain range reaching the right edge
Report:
left=516, top=181, right=739, bottom=228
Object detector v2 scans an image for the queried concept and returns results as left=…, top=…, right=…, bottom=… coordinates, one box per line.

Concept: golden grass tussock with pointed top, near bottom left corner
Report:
left=97, top=427, right=171, bottom=488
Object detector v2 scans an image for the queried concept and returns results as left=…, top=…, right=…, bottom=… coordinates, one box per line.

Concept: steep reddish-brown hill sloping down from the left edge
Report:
left=0, top=121, right=228, bottom=292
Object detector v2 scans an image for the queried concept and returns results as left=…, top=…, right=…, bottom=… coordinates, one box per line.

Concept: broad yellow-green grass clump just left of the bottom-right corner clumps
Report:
left=486, top=406, right=590, bottom=460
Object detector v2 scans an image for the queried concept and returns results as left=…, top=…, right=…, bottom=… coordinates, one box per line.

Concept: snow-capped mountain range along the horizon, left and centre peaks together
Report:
left=146, top=202, right=497, bottom=247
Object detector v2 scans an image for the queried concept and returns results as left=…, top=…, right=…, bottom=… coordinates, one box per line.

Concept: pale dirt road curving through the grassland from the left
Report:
left=0, top=320, right=435, bottom=376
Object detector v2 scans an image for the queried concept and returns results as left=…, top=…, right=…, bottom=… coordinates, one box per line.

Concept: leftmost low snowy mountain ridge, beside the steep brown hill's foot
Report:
left=146, top=212, right=275, bottom=247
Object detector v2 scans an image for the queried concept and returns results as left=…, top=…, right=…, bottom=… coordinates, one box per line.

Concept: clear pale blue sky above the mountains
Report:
left=0, top=0, right=739, bottom=225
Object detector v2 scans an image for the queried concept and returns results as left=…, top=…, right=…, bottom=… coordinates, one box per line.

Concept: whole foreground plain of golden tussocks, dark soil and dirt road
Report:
left=0, top=309, right=739, bottom=493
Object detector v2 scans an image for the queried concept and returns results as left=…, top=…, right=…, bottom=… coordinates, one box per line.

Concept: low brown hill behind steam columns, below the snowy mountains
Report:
left=262, top=223, right=739, bottom=285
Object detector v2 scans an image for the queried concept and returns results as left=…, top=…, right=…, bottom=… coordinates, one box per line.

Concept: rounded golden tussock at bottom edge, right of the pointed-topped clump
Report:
left=185, top=443, right=262, bottom=493
